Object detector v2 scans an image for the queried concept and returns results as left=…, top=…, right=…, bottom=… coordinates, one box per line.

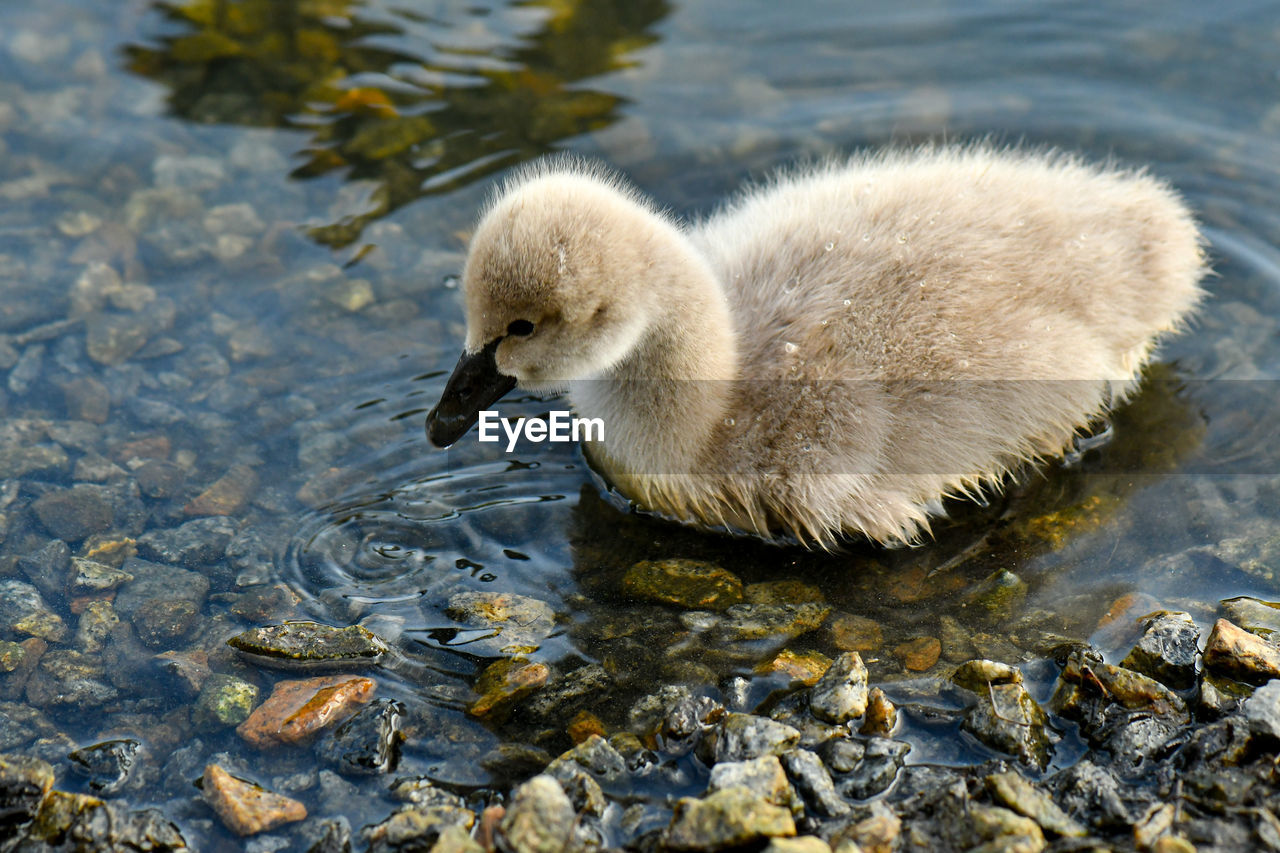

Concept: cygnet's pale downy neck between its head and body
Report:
left=570, top=243, right=737, bottom=480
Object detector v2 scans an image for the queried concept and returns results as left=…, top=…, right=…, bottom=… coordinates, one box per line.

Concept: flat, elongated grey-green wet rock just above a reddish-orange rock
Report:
left=227, top=621, right=390, bottom=669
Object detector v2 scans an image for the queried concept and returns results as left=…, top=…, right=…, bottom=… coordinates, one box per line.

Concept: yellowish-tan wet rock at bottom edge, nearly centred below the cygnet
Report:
left=663, top=788, right=796, bottom=850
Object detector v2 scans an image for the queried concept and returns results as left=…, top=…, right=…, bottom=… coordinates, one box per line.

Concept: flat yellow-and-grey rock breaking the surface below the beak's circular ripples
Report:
left=444, top=592, right=556, bottom=657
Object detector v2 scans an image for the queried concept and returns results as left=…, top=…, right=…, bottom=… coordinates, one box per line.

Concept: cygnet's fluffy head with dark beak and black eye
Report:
left=428, top=164, right=672, bottom=447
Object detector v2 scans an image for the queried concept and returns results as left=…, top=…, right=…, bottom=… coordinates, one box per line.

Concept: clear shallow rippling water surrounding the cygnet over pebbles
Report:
left=0, top=0, right=1280, bottom=838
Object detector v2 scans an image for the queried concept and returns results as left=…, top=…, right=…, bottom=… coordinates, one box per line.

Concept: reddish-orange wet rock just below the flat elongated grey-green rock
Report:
left=236, top=675, right=375, bottom=748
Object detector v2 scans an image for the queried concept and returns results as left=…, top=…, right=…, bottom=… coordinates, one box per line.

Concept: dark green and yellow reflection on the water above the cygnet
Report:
left=125, top=0, right=669, bottom=248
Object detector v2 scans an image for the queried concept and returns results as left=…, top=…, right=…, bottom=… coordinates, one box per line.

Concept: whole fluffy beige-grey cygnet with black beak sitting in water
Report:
left=428, top=146, right=1204, bottom=548
